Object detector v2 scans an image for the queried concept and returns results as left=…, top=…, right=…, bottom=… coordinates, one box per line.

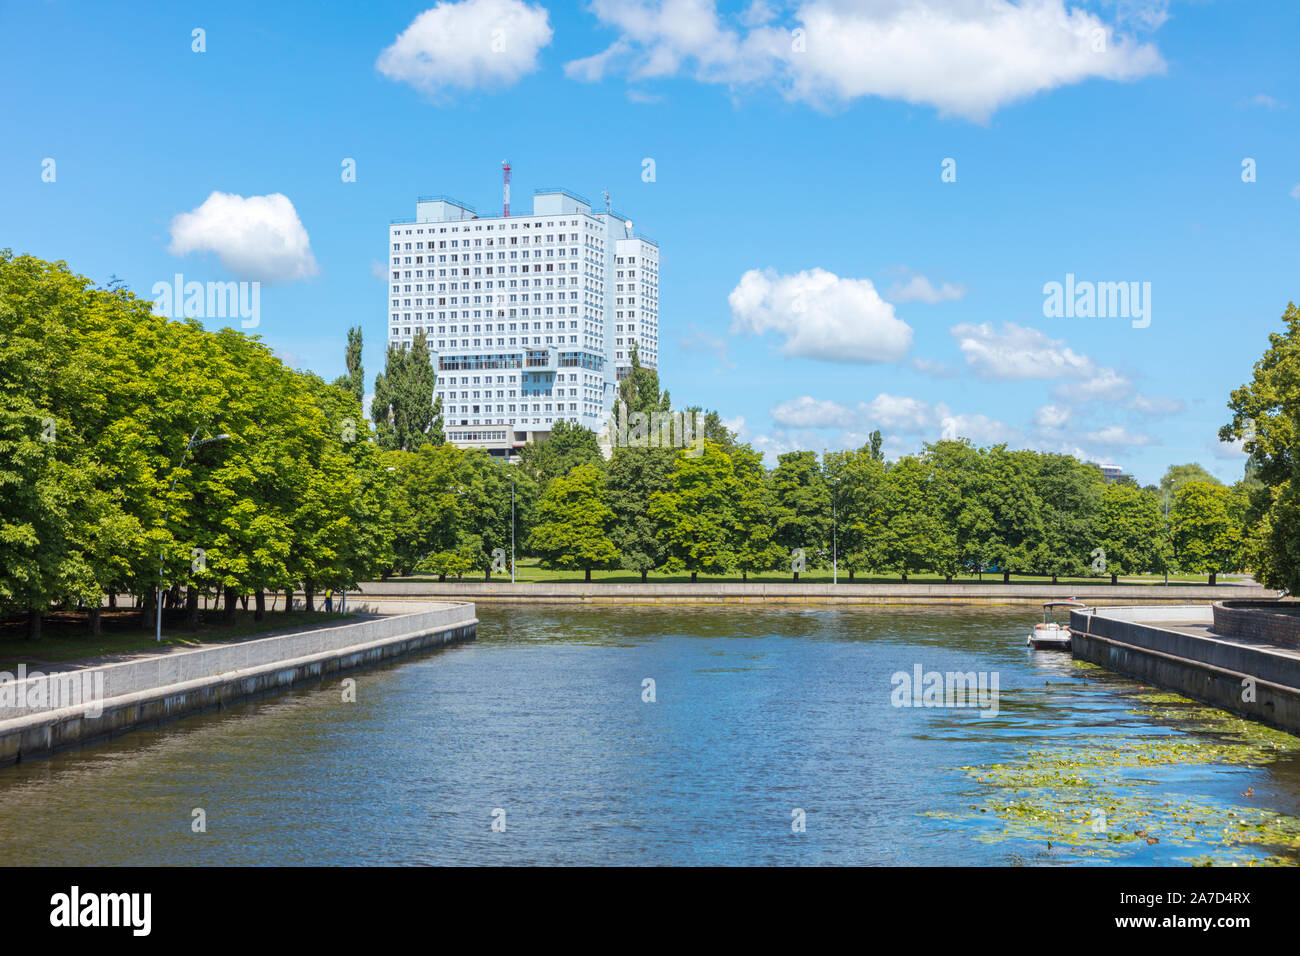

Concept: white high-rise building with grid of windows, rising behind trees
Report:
left=387, top=189, right=659, bottom=457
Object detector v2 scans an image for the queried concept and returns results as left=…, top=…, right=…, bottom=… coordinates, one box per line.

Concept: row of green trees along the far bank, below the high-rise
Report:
left=376, top=327, right=1249, bottom=581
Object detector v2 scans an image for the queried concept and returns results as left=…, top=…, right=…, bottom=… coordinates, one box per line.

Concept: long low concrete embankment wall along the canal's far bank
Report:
left=348, top=580, right=1275, bottom=607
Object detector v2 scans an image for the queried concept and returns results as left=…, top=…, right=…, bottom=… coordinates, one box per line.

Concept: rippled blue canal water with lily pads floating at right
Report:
left=0, top=605, right=1300, bottom=865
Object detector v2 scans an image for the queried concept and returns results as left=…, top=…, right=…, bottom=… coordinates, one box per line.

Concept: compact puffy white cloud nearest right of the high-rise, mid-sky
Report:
left=727, top=269, right=911, bottom=362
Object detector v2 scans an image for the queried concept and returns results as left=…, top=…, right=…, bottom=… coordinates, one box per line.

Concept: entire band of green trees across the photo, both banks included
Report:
left=0, top=251, right=1300, bottom=642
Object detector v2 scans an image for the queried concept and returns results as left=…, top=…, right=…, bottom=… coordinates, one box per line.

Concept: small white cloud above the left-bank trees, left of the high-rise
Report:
left=168, top=193, right=319, bottom=282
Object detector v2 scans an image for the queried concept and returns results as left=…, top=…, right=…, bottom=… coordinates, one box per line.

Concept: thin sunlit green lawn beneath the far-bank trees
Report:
left=390, top=558, right=1244, bottom=585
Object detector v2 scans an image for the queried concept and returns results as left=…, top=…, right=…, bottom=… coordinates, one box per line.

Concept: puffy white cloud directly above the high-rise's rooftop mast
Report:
left=374, top=0, right=554, bottom=95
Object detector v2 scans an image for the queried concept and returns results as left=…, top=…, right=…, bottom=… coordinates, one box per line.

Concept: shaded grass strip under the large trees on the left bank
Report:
left=0, top=607, right=351, bottom=671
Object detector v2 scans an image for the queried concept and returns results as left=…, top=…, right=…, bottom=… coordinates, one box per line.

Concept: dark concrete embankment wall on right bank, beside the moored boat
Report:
left=1070, top=606, right=1300, bottom=734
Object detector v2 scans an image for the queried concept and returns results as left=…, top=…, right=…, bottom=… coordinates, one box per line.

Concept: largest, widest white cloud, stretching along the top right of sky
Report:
left=566, top=0, right=1165, bottom=121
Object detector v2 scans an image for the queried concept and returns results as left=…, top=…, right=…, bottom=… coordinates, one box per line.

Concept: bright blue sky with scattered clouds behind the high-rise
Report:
left=0, top=0, right=1300, bottom=483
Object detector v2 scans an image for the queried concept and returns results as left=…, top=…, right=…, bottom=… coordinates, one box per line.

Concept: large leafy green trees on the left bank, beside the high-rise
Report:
left=0, top=250, right=397, bottom=636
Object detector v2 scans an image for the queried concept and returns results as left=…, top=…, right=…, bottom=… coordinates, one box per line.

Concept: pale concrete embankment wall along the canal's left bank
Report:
left=0, top=602, right=478, bottom=766
